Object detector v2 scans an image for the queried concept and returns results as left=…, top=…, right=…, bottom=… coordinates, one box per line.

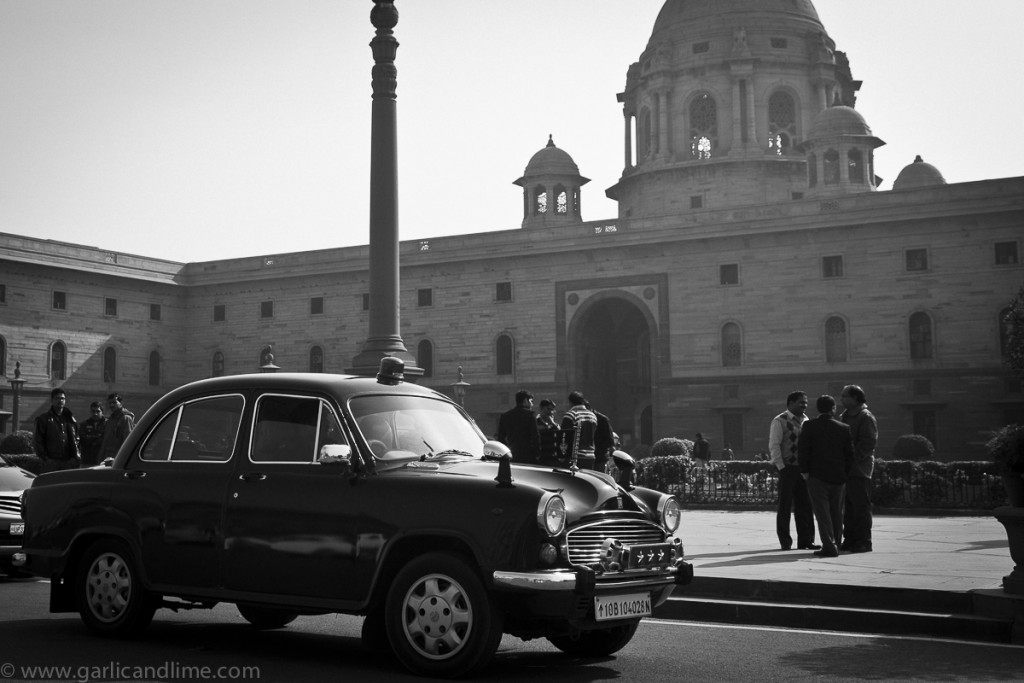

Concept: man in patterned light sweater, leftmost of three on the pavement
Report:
left=768, top=391, right=821, bottom=550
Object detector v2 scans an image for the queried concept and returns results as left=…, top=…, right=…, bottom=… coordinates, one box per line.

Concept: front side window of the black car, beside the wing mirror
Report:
left=250, top=394, right=347, bottom=463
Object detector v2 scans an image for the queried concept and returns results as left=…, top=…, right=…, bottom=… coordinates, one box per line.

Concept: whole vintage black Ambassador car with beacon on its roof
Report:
left=17, top=358, right=693, bottom=677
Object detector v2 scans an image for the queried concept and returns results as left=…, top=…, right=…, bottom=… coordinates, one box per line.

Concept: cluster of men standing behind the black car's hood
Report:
left=495, top=390, right=615, bottom=472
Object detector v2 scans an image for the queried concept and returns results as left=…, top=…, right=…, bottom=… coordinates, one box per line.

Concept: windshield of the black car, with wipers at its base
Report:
left=349, top=395, right=485, bottom=460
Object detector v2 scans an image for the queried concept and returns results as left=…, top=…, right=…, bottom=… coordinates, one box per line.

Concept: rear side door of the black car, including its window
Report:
left=114, top=393, right=246, bottom=592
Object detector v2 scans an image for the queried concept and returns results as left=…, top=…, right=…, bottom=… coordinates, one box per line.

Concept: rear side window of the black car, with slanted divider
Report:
left=140, top=394, right=245, bottom=463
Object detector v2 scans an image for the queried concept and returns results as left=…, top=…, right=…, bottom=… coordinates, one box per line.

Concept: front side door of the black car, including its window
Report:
left=224, top=394, right=391, bottom=604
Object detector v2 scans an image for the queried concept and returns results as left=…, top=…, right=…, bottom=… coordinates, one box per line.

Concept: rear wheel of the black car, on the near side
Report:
left=75, top=539, right=159, bottom=638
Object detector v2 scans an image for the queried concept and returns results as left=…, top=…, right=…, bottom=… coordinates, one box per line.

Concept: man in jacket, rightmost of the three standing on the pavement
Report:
left=840, top=384, right=879, bottom=553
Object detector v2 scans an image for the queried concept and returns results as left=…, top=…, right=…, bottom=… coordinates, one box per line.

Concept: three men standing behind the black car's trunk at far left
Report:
left=35, top=388, right=135, bottom=472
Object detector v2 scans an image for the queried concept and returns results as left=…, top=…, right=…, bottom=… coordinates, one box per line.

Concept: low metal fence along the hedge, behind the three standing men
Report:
left=636, top=456, right=1007, bottom=510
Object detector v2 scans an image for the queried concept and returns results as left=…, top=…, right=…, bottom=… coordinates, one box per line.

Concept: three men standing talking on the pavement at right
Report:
left=768, top=384, right=879, bottom=557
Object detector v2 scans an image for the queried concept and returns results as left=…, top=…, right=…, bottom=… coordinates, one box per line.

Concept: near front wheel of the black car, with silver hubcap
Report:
left=384, top=553, right=503, bottom=678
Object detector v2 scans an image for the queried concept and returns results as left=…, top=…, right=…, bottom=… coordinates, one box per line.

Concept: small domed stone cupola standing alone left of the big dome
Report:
left=514, top=135, right=590, bottom=227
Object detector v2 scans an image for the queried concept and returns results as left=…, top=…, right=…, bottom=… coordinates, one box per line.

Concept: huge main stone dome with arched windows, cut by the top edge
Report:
left=606, top=0, right=860, bottom=220
